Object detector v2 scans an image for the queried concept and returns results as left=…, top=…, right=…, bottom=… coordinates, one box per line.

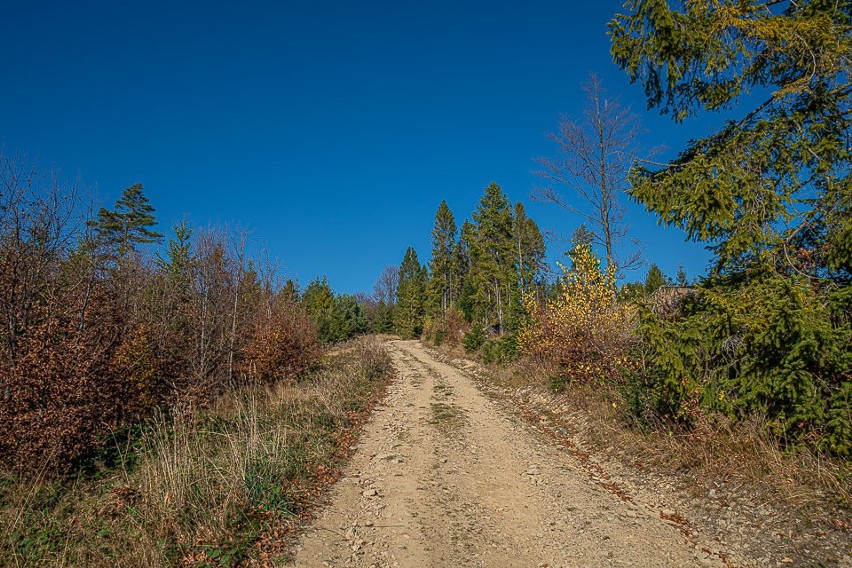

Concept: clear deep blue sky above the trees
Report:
left=0, top=0, right=724, bottom=293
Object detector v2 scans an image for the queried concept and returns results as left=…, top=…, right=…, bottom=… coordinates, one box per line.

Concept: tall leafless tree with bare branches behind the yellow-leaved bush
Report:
left=532, top=73, right=642, bottom=274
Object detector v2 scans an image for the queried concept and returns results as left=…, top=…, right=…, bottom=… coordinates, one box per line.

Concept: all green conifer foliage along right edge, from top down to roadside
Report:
left=610, top=0, right=852, bottom=455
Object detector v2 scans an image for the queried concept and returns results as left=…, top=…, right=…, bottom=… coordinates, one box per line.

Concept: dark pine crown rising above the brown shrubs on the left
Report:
left=89, top=183, right=163, bottom=256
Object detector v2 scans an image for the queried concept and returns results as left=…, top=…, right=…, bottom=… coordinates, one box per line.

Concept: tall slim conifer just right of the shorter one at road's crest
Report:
left=428, top=201, right=457, bottom=316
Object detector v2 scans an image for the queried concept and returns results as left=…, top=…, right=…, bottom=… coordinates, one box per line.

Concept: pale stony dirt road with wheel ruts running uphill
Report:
left=295, top=341, right=724, bottom=568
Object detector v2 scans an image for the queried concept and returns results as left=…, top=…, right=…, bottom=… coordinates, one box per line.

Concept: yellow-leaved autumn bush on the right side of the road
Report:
left=518, top=245, right=633, bottom=386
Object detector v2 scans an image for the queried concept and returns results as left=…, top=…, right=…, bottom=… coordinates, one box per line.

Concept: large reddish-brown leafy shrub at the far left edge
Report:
left=0, top=291, right=151, bottom=471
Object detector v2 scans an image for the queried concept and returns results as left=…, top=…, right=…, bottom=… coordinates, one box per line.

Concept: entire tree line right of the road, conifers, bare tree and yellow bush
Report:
left=382, top=0, right=852, bottom=456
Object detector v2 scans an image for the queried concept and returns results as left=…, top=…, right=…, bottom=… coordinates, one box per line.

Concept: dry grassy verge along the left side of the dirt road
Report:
left=0, top=340, right=392, bottom=567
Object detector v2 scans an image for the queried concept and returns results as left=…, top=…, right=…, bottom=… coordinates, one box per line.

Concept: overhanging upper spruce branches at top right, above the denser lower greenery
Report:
left=610, top=0, right=852, bottom=282
